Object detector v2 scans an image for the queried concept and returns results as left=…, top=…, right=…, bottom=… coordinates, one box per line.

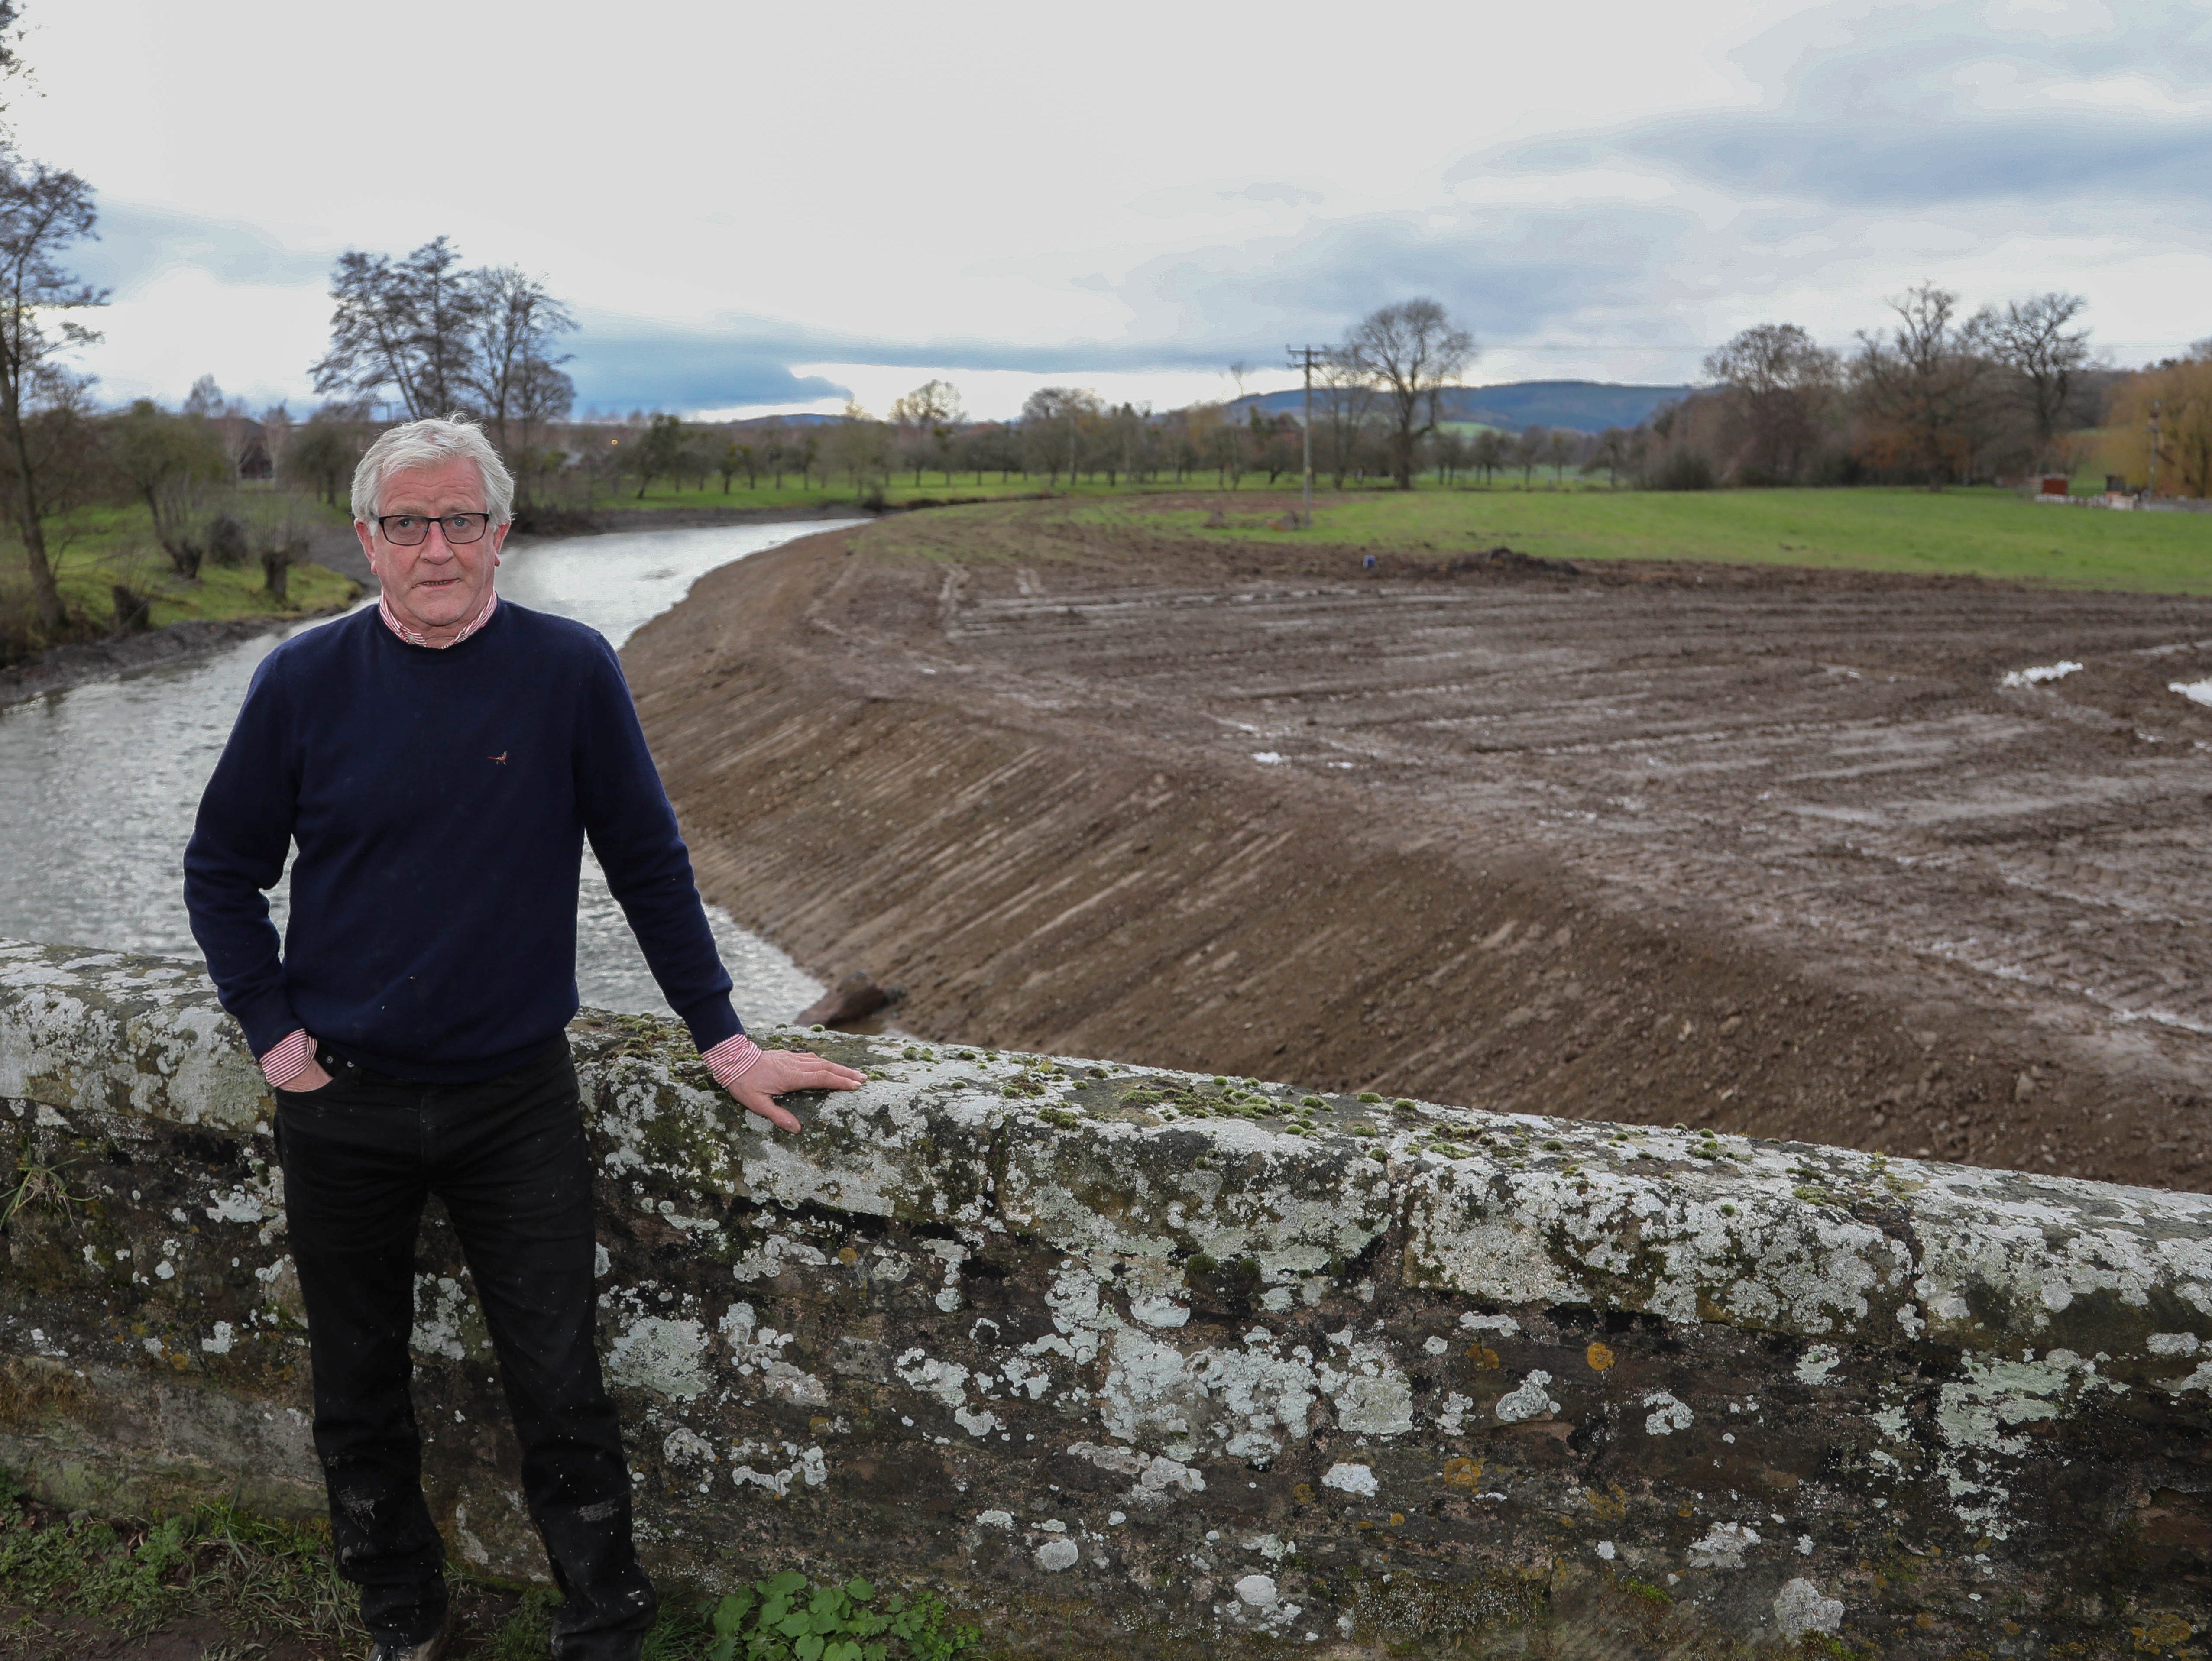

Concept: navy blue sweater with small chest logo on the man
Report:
left=184, top=599, right=741, bottom=1084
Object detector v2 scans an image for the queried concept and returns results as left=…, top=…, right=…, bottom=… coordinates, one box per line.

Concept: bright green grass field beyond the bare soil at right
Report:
left=1097, top=489, right=2212, bottom=595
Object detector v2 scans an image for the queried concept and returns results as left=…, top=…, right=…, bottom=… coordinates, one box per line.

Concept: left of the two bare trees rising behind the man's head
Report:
left=312, top=236, right=480, bottom=420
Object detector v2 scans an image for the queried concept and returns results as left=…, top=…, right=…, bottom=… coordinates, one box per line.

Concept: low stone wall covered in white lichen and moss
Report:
left=0, top=944, right=2212, bottom=1657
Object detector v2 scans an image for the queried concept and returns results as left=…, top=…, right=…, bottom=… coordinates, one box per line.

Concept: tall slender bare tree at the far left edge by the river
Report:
left=0, top=152, right=108, bottom=635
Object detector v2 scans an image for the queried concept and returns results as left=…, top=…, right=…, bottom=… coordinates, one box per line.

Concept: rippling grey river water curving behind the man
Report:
left=0, top=520, right=849, bottom=1022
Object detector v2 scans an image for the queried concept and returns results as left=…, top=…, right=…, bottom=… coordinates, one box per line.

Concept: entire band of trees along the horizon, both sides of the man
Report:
left=0, top=157, right=2212, bottom=668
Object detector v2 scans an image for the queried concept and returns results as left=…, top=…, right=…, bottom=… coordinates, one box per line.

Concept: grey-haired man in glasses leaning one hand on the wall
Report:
left=184, top=420, right=861, bottom=1661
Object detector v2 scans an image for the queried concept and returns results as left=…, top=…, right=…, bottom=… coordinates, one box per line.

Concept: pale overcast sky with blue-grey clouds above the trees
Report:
left=11, top=0, right=2212, bottom=416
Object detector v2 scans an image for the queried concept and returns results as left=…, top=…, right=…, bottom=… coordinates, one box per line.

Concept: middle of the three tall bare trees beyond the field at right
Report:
left=1854, top=283, right=1991, bottom=491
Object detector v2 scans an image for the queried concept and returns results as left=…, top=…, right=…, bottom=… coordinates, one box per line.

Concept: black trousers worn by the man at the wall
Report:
left=276, top=1037, right=655, bottom=1661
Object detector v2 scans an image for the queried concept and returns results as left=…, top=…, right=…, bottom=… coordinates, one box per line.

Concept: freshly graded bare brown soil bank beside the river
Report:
left=628, top=504, right=2212, bottom=1188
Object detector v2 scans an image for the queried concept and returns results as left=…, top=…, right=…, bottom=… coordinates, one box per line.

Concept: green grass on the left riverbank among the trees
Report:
left=0, top=504, right=356, bottom=628
